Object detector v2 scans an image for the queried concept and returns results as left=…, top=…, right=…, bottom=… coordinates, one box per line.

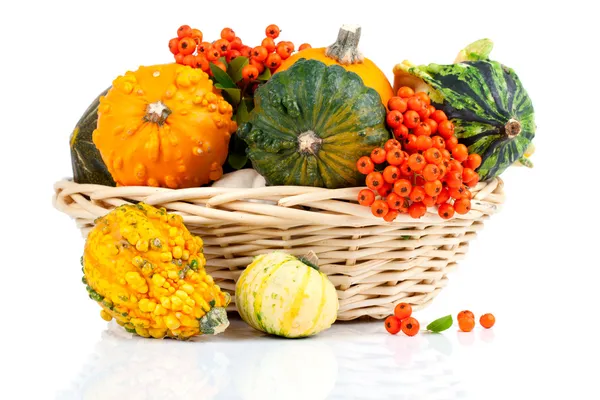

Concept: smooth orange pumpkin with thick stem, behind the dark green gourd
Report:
left=276, top=25, right=394, bottom=107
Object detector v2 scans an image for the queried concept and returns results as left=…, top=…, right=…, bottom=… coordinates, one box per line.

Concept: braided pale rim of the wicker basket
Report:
left=53, top=178, right=504, bottom=227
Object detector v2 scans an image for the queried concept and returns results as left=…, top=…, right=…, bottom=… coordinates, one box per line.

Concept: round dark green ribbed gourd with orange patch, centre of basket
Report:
left=238, top=59, right=390, bottom=189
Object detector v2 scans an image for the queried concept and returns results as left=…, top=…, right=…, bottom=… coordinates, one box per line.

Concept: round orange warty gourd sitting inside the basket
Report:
left=93, top=64, right=237, bottom=189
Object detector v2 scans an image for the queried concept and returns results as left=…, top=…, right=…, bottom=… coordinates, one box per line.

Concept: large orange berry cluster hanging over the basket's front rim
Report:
left=356, top=86, right=481, bottom=222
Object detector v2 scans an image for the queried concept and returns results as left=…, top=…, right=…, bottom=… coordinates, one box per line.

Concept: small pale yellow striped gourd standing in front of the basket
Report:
left=235, top=252, right=339, bottom=338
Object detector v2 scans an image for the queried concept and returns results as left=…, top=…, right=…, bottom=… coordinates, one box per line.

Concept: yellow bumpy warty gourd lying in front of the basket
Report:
left=82, top=203, right=230, bottom=339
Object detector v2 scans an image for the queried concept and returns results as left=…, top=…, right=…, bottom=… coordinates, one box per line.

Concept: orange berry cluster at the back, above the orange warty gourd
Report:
left=169, top=24, right=311, bottom=81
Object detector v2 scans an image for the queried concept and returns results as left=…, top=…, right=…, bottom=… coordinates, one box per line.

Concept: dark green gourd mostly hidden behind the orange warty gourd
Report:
left=70, top=89, right=115, bottom=186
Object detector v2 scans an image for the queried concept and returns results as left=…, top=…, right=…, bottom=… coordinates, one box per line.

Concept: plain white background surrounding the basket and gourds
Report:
left=0, top=0, right=600, bottom=399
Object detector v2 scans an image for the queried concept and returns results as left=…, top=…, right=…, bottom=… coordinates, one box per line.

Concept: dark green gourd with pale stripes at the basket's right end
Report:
left=394, top=39, right=536, bottom=181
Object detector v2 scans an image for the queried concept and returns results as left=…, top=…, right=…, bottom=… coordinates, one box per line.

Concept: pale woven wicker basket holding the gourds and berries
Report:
left=54, top=178, right=504, bottom=320
